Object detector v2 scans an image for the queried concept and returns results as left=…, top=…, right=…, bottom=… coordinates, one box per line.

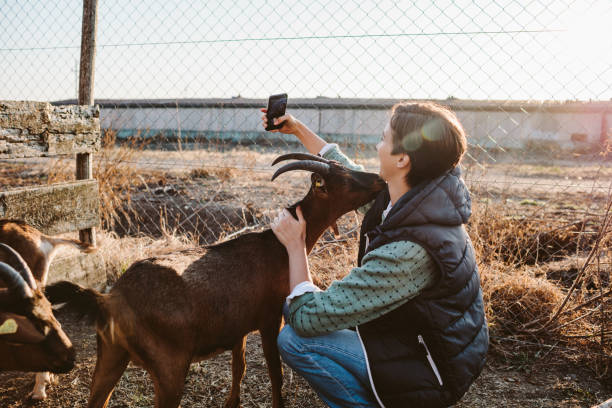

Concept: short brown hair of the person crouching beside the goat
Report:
left=389, top=102, right=467, bottom=187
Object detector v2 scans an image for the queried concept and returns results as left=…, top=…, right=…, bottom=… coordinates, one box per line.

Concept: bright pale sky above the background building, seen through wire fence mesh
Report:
left=0, top=0, right=612, bottom=100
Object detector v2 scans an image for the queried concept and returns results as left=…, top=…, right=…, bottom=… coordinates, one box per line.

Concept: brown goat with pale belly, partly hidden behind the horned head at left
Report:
left=0, top=220, right=96, bottom=400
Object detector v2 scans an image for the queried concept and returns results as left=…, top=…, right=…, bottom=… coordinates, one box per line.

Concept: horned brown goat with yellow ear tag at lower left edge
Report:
left=0, top=244, right=75, bottom=373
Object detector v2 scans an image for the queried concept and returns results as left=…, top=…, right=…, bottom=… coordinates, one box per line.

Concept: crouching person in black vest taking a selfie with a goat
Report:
left=262, top=103, right=488, bottom=407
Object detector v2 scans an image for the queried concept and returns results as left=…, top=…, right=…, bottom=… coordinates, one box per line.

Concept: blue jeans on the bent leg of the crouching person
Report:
left=277, top=304, right=378, bottom=408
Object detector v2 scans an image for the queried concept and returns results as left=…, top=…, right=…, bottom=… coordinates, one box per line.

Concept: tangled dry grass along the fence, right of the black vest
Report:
left=468, top=194, right=612, bottom=378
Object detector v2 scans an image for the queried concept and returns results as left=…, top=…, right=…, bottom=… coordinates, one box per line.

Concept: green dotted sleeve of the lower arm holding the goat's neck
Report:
left=288, top=241, right=437, bottom=336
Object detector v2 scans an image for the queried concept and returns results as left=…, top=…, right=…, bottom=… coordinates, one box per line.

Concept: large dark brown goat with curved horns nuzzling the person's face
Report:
left=47, top=154, right=384, bottom=408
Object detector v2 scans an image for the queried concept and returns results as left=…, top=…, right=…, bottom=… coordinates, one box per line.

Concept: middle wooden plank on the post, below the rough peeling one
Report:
left=0, top=180, right=100, bottom=235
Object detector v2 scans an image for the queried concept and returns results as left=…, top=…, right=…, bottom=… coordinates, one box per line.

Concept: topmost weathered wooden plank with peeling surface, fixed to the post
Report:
left=0, top=101, right=100, bottom=159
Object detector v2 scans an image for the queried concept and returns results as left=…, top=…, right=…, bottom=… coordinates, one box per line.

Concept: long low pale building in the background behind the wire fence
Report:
left=54, top=97, right=612, bottom=156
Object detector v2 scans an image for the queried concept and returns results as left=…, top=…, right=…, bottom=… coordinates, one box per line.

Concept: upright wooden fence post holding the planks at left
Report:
left=76, top=0, right=98, bottom=246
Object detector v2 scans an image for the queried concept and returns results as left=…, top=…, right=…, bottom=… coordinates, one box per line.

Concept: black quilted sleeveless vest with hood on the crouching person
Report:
left=357, top=168, right=489, bottom=408
